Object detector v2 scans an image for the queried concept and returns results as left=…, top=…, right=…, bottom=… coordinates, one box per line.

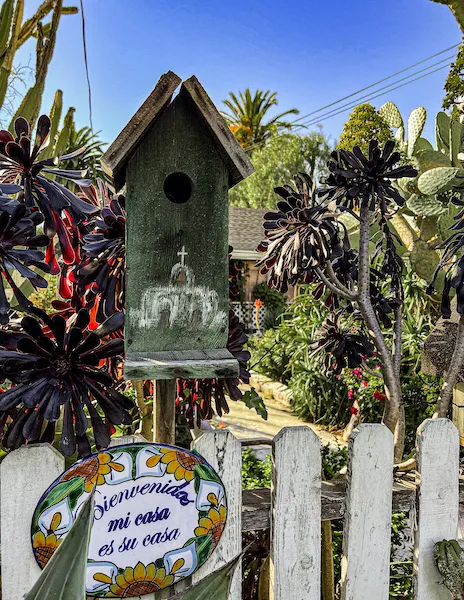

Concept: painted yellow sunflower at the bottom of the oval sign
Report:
left=104, top=562, right=174, bottom=598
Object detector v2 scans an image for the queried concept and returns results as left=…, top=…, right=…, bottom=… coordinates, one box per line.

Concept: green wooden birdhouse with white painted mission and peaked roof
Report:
left=102, top=72, right=253, bottom=379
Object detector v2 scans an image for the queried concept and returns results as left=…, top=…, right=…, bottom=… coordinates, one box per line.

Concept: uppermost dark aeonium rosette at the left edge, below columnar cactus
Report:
left=0, top=115, right=99, bottom=264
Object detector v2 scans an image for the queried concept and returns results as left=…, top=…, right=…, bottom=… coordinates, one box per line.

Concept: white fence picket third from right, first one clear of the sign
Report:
left=271, top=427, right=321, bottom=600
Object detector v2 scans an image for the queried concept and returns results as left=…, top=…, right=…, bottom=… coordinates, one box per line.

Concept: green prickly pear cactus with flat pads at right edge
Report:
left=379, top=102, right=464, bottom=280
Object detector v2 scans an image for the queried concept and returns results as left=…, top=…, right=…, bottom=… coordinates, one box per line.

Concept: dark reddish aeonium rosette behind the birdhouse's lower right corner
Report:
left=177, top=310, right=250, bottom=427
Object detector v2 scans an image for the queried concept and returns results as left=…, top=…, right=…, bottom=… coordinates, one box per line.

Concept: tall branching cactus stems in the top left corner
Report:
left=0, top=0, right=78, bottom=124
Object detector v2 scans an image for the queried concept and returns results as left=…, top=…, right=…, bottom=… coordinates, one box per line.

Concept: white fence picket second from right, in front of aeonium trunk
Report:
left=342, top=424, right=393, bottom=600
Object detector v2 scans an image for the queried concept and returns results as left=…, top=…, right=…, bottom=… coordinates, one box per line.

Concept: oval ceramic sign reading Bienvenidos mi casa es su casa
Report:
left=32, top=444, right=227, bottom=598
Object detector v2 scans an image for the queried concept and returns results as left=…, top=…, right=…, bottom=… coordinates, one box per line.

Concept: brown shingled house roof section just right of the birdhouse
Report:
left=229, top=206, right=269, bottom=260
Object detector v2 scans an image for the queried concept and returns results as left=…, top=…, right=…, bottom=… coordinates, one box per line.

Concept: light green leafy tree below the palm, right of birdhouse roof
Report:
left=229, top=130, right=331, bottom=208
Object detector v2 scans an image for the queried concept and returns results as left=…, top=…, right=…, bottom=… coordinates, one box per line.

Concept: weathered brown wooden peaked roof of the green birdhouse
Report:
left=101, top=71, right=254, bottom=189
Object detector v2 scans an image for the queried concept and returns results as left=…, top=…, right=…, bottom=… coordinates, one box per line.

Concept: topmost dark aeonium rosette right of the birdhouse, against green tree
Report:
left=318, top=140, right=417, bottom=213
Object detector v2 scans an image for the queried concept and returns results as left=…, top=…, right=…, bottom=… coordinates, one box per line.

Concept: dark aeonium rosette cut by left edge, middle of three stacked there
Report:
left=0, top=202, right=49, bottom=324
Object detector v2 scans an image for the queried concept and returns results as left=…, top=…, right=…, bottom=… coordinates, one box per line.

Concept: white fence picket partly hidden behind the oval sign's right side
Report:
left=192, top=431, right=242, bottom=600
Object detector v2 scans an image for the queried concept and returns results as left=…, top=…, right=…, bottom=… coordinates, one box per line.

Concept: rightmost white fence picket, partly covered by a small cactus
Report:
left=414, top=419, right=459, bottom=600
